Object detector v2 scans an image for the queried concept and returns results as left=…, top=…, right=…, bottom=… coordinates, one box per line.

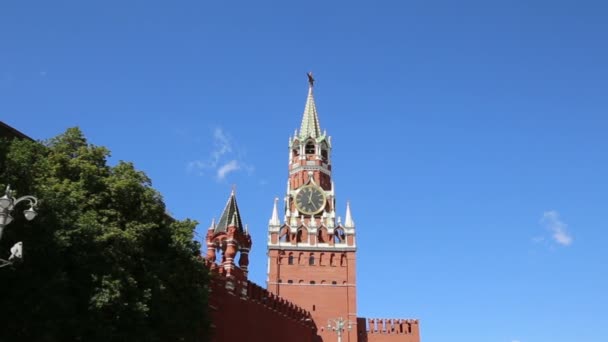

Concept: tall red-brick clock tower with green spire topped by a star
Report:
left=267, top=73, right=357, bottom=342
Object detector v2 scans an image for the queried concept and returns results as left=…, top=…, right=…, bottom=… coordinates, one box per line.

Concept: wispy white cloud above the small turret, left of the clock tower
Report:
left=188, top=127, right=253, bottom=181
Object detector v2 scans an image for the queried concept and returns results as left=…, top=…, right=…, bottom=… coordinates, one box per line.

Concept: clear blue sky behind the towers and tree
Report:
left=0, top=1, right=608, bottom=342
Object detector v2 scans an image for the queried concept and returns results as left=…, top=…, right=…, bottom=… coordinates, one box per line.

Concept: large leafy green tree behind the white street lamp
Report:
left=0, top=128, right=209, bottom=341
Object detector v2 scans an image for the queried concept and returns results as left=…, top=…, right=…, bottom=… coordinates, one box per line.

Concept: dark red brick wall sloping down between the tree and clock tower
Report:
left=209, top=274, right=318, bottom=342
